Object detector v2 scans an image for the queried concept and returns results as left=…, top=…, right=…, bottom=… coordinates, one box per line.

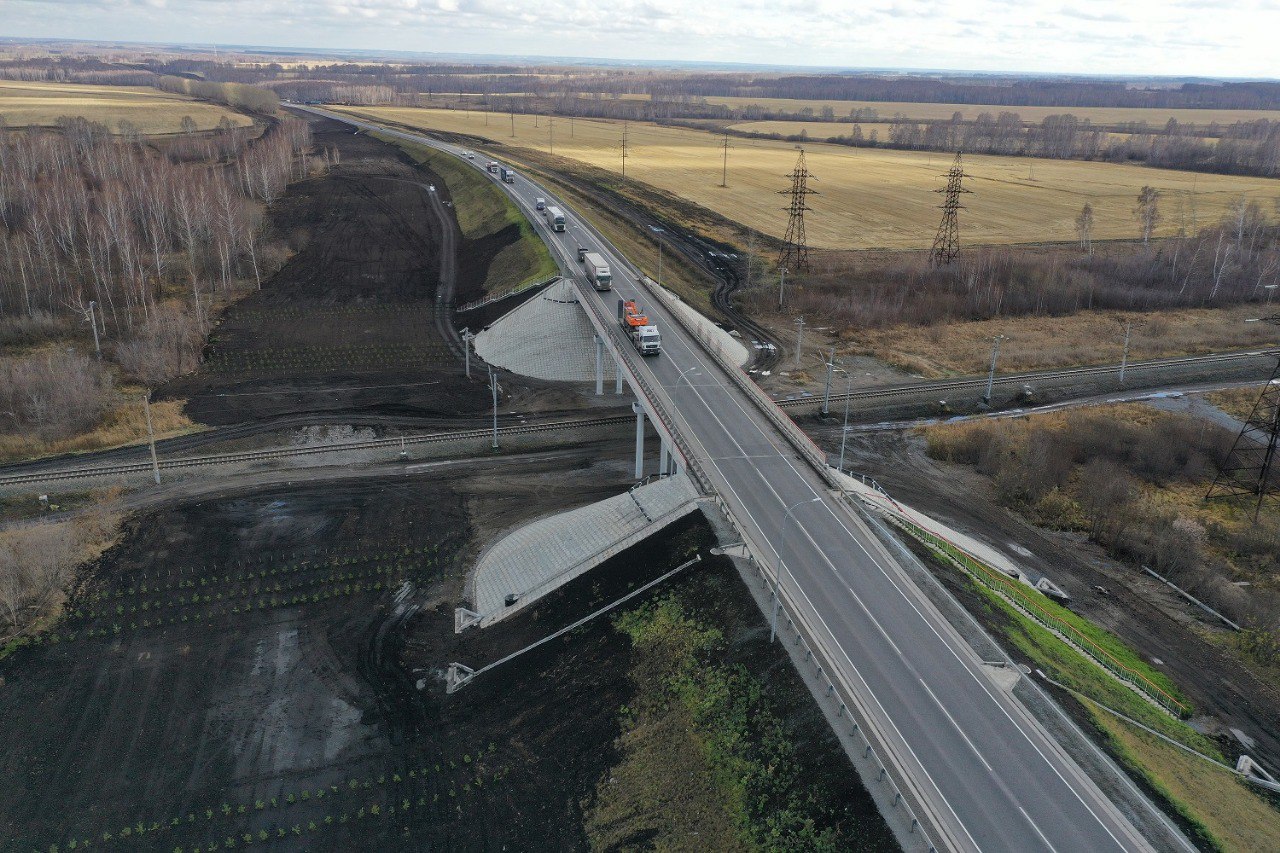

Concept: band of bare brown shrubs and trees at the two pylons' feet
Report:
left=768, top=211, right=1280, bottom=328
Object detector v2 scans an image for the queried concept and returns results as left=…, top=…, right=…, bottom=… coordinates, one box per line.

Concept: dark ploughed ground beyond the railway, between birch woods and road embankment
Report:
left=163, top=119, right=488, bottom=425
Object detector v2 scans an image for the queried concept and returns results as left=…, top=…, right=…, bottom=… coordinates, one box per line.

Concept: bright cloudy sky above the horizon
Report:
left=0, top=0, right=1280, bottom=78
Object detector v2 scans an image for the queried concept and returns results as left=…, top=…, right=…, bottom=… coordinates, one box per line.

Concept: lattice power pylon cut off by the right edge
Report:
left=1204, top=314, right=1280, bottom=521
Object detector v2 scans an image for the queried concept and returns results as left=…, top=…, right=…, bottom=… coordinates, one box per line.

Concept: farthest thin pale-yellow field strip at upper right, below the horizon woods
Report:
left=703, top=96, right=1280, bottom=127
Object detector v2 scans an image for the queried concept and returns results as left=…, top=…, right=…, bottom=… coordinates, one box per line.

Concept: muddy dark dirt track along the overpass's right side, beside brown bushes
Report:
left=834, top=432, right=1280, bottom=767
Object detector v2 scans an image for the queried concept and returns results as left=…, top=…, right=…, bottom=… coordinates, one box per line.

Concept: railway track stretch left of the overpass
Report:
left=0, top=415, right=634, bottom=488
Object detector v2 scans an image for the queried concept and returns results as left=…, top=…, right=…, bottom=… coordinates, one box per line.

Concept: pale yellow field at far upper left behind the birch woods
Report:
left=0, top=81, right=252, bottom=136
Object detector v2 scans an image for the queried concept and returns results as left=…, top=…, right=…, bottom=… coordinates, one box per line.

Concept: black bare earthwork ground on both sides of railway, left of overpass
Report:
left=0, top=114, right=895, bottom=853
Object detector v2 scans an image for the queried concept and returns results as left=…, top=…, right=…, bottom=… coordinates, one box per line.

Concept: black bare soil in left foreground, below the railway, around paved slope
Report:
left=0, top=440, right=883, bottom=850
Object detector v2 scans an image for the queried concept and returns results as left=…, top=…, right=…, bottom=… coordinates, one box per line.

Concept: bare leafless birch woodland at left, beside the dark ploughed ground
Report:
left=0, top=118, right=323, bottom=439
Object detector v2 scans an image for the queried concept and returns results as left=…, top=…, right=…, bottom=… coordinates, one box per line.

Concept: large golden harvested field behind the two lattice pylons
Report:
left=334, top=108, right=1280, bottom=248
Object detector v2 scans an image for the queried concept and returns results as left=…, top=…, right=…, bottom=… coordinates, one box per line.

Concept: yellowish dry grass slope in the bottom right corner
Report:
left=1093, top=711, right=1280, bottom=853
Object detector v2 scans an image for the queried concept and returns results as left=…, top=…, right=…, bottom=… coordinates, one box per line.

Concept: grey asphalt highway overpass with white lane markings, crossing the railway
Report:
left=298, top=108, right=1193, bottom=853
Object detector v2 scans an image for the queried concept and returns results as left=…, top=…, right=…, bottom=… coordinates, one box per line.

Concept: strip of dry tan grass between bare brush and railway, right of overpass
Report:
left=839, top=306, right=1280, bottom=378
